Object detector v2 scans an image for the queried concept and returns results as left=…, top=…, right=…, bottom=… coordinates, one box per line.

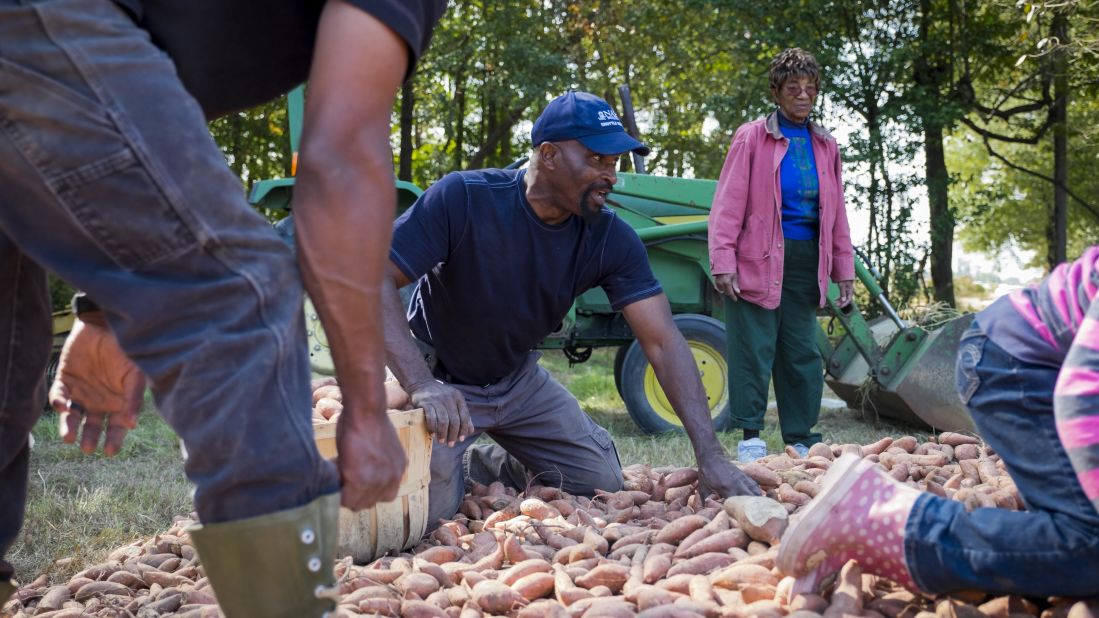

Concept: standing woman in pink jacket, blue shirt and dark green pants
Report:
left=709, top=47, right=855, bottom=462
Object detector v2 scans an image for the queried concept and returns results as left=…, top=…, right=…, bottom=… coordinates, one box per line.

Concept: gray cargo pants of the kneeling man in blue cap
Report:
left=428, top=352, right=622, bottom=528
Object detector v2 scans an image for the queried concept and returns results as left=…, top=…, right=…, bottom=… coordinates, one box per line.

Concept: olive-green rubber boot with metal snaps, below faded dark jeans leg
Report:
left=189, top=492, right=340, bottom=618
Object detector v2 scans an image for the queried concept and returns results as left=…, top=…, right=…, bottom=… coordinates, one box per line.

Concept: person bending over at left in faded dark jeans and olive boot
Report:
left=0, top=0, right=445, bottom=618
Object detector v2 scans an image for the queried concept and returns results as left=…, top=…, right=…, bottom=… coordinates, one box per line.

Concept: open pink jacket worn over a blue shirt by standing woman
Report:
left=709, top=113, right=855, bottom=309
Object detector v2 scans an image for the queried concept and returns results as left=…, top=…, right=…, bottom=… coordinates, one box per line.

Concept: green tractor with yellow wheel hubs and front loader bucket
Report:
left=249, top=88, right=974, bottom=433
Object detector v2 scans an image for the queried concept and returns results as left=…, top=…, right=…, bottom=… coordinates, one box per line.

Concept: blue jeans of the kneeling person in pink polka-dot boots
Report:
left=904, top=321, right=1099, bottom=597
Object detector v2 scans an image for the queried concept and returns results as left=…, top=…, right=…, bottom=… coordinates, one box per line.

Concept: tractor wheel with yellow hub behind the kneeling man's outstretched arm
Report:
left=615, top=313, right=731, bottom=433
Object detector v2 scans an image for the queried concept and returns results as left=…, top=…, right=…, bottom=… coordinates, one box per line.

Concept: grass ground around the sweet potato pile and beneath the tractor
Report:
left=8, top=350, right=923, bottom=582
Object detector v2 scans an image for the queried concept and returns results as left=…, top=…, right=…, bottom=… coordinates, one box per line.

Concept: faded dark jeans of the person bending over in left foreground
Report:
left=0, top=0, right=338, bottom=577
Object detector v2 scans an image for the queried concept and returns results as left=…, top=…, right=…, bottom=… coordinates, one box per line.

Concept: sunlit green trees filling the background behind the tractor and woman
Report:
left=211, top=0, right=1099, bottom=304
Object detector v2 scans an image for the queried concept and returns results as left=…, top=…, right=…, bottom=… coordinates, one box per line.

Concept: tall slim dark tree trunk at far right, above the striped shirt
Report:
left=1048, top=11, right=1068, bottom=271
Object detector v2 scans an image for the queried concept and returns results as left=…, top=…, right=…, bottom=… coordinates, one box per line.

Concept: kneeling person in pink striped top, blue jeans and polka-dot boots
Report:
left=778, top=246, right=1099, bottom=597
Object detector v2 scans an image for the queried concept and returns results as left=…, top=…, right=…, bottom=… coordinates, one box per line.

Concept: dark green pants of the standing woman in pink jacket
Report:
left=725, top=240, right=824, bottom=446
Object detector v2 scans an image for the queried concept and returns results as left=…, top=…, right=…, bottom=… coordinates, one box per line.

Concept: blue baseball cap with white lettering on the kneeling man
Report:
left=531, top=90, right=650, bottom=156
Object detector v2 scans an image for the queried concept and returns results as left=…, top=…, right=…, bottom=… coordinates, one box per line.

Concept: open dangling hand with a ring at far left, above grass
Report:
left=49, top=319, right=145, bottom=456
